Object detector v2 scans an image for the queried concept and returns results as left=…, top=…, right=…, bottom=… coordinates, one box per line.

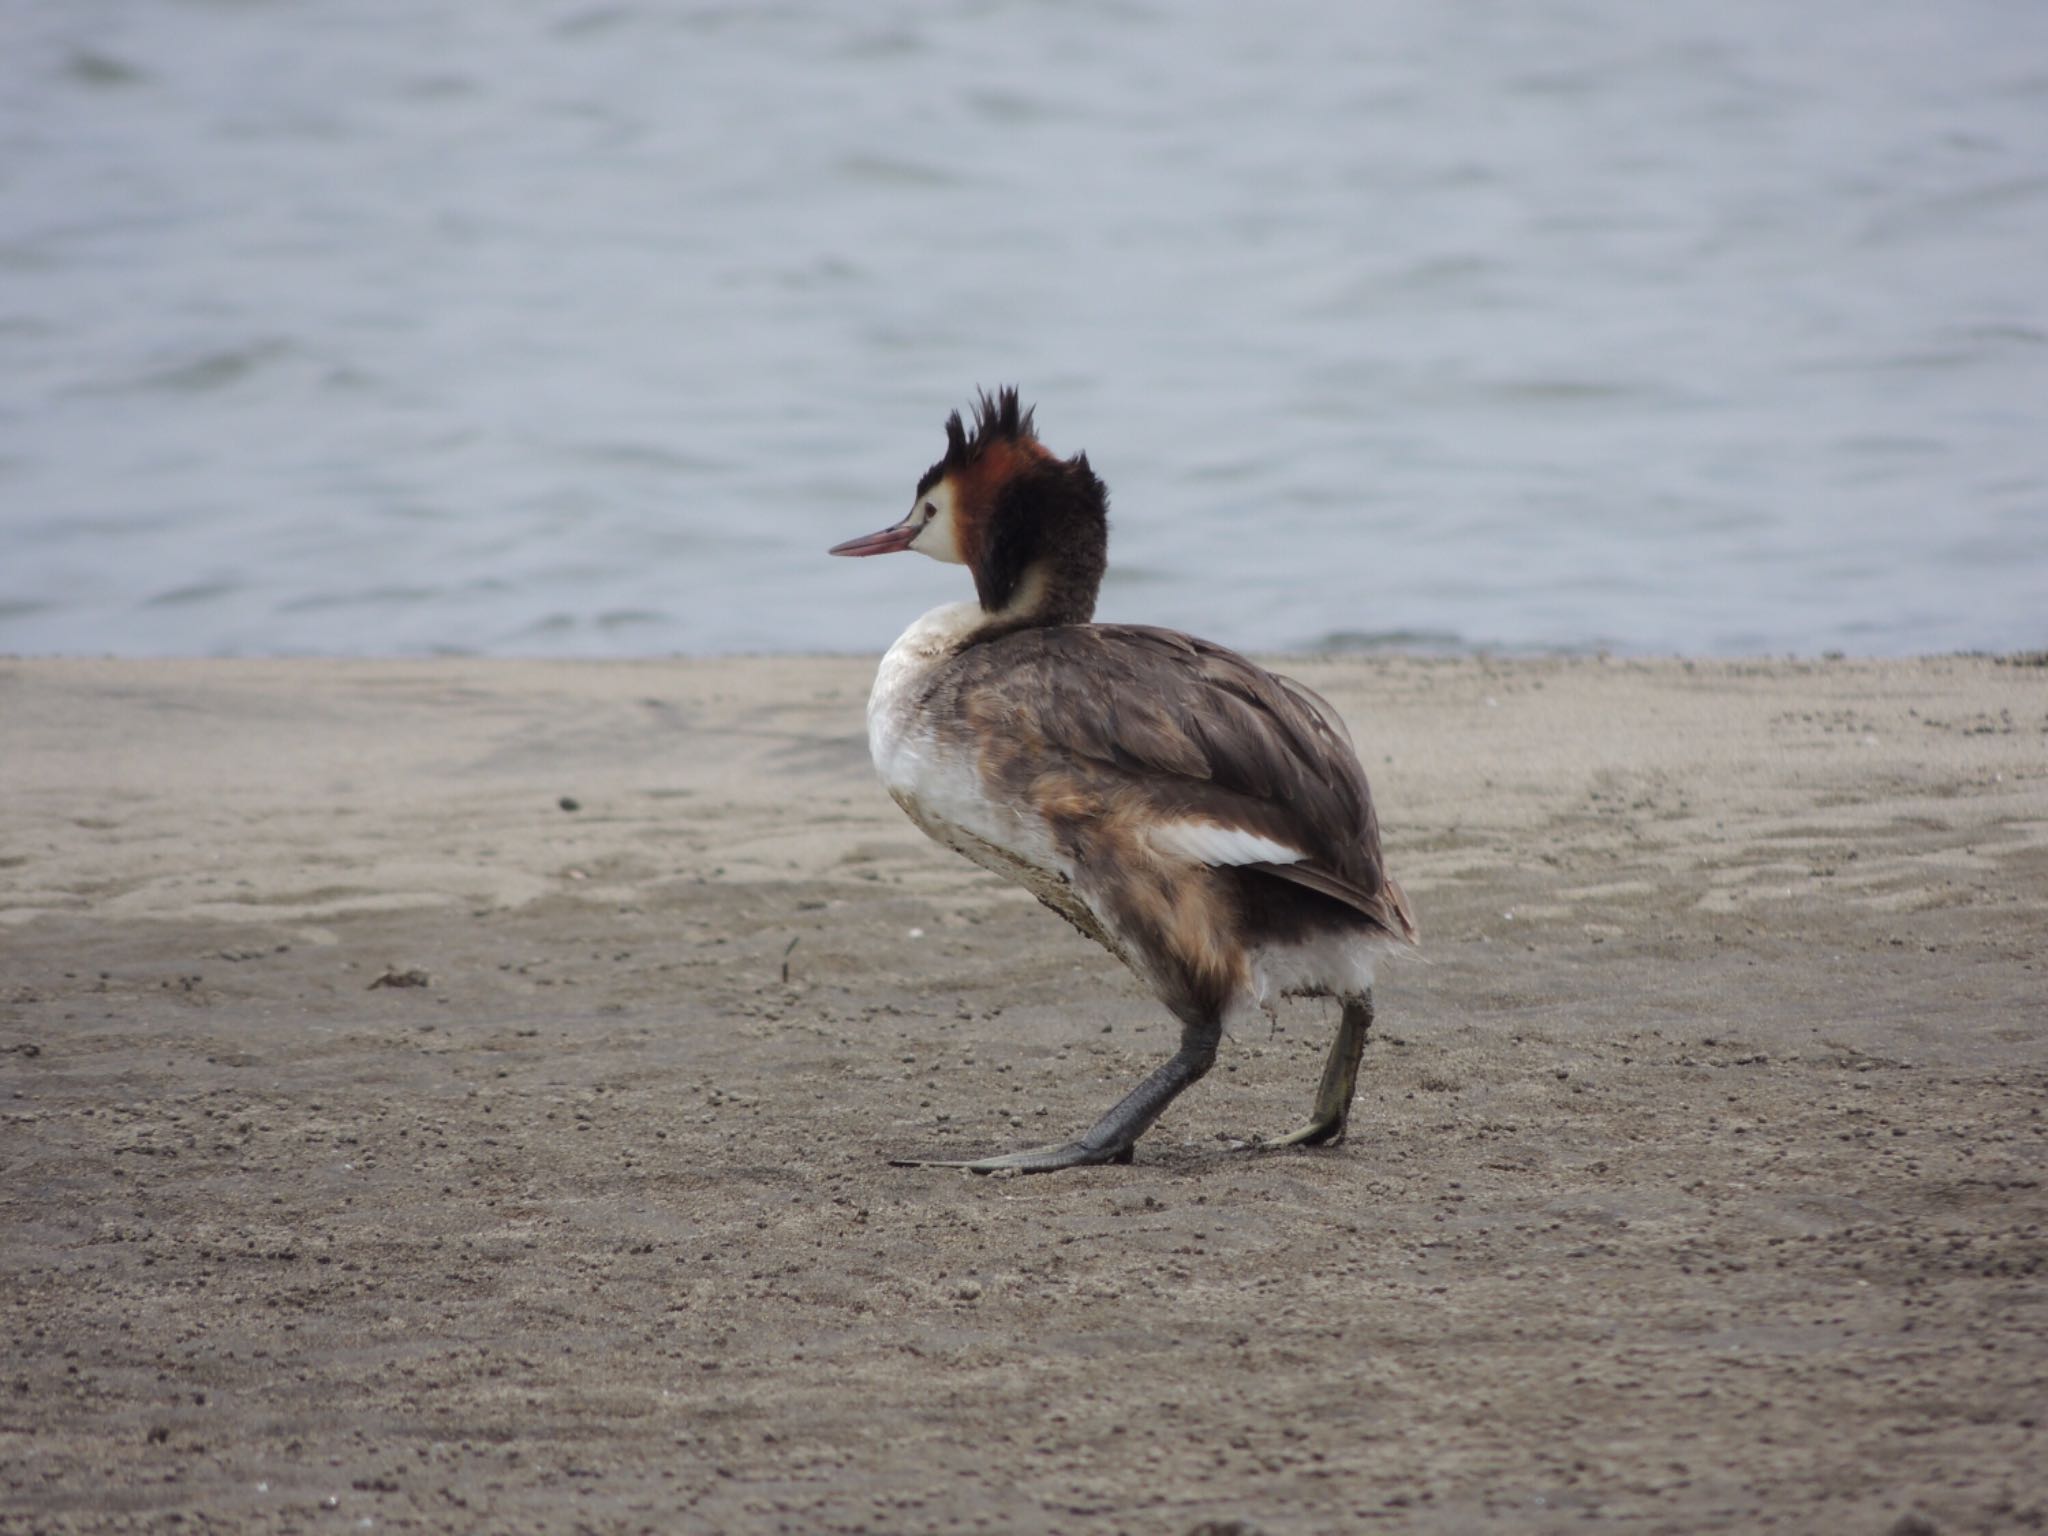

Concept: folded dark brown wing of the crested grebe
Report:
left=934, top=625, right=1415, bottom=940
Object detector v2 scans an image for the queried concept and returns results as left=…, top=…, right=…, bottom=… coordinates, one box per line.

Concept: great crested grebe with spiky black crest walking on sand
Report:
left=829, top=387, right=1419, bottom=1174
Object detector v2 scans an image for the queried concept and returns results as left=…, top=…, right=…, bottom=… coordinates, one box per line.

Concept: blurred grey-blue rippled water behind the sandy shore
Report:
left=0, top=0, right=2048, bottom=655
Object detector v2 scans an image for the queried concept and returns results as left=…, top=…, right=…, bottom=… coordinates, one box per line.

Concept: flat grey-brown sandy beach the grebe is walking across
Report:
left=0, top=657, right=2048, bottom=1536
